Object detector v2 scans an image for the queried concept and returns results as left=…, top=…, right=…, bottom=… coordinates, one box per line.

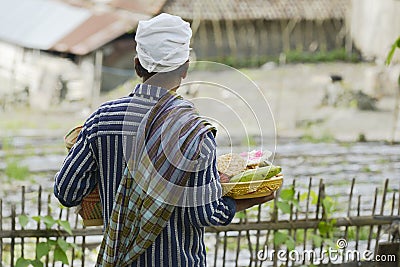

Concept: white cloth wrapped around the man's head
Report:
left=135, top=13, right=192, bottom=73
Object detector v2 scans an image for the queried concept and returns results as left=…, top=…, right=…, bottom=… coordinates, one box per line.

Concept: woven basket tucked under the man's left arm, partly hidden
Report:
left=64, top=126, right=103, bottom=226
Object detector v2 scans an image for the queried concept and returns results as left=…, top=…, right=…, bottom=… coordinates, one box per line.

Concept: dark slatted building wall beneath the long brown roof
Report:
left=192, top=20, right=345, bottom=63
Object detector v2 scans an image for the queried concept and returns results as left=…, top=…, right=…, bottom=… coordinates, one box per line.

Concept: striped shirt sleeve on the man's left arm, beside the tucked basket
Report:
left=54, top=120, right=97, bottom=207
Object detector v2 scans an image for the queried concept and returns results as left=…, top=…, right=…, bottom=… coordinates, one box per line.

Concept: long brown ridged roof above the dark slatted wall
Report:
left=163, top=0, right=351, bottom=20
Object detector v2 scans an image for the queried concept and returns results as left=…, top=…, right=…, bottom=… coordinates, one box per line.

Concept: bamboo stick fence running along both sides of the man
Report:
left=0, top=178, right=400, bottom=267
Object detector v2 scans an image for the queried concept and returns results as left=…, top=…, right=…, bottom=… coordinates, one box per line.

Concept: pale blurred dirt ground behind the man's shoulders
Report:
left=0, top=63, right=400, bottom=144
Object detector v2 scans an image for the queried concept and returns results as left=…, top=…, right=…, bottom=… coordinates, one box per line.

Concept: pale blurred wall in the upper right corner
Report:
left=350, top=0, right=400, bottom=62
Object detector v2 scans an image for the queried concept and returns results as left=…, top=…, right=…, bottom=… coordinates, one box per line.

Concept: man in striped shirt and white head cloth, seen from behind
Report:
left=54, top=13, right=273, bottom=266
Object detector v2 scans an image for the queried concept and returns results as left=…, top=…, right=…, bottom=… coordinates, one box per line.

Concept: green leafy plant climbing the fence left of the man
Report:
left=15, top=214, right=78, bottom=267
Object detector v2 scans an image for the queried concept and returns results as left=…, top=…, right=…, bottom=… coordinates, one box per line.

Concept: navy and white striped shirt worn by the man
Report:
left=54, top=84, right=236, bottom=266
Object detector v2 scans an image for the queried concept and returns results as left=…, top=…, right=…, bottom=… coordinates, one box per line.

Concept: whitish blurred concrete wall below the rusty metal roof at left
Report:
left=0, top=42, right=94, bottom=110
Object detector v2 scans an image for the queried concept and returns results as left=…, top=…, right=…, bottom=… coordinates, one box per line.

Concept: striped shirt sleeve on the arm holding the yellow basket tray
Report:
left=188, top=133, right=236, bottom=227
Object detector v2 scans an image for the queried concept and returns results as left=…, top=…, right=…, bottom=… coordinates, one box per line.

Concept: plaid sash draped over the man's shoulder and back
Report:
left=96, top=92, right=214, bottom=267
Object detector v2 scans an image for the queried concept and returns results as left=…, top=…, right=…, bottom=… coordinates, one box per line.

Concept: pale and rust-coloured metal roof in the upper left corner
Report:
left=0, top=0, right=165, bottom=55
